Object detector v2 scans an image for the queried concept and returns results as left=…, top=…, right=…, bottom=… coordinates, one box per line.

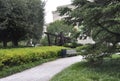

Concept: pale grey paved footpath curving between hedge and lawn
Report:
left=0, top=56, right=82, bottom=81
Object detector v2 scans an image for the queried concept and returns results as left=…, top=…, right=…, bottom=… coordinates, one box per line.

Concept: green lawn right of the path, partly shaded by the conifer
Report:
left=51, top=55, right=120, bottom=81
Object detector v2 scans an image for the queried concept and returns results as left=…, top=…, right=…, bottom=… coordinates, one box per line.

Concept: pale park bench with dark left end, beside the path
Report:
left=61, top=49, right=78, bottom=57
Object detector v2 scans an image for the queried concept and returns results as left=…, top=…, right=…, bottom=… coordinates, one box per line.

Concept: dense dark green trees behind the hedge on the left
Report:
left=0, top=0, right=44, bottom=47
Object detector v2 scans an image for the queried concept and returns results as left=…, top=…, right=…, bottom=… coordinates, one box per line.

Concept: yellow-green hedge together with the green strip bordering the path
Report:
left=0, top=46, right=64, bottom=78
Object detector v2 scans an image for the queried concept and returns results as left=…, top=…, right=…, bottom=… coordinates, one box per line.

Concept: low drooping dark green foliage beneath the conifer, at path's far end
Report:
left=76, top=44, right=112, bottom=63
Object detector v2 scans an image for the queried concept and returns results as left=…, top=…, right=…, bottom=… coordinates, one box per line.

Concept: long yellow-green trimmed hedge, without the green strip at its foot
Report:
left=0, top=46, right=64, bottom=69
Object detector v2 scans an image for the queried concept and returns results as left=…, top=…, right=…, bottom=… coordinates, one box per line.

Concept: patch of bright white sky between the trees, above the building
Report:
left=43, top=0, right=71, bottom=23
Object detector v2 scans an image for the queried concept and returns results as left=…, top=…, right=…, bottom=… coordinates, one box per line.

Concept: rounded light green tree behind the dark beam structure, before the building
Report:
left=47, top=20, right=73, bottom=43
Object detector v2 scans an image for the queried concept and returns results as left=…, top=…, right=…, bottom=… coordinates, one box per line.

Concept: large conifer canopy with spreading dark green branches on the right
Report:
left=59, top=0, right=120, bottom=62
